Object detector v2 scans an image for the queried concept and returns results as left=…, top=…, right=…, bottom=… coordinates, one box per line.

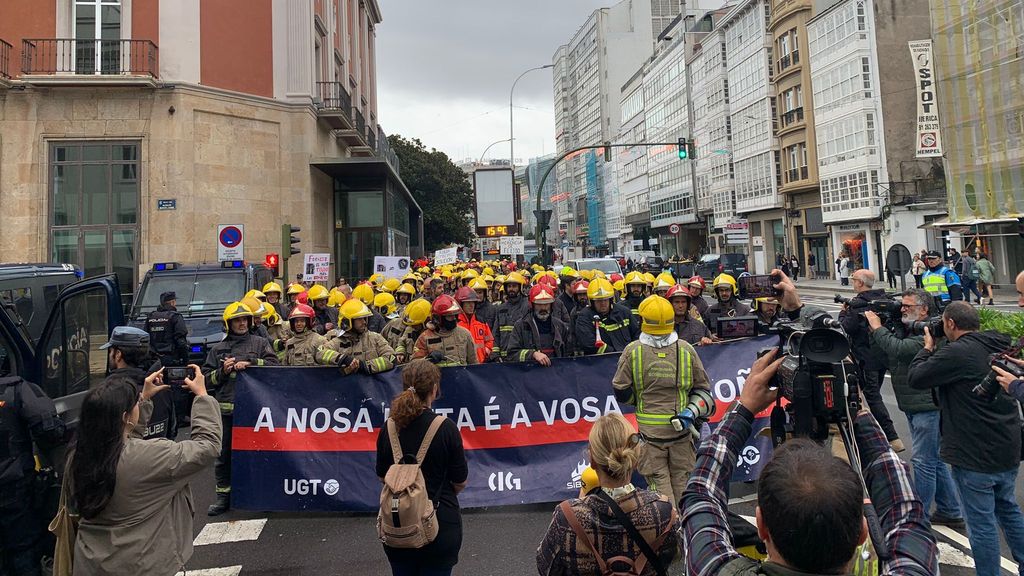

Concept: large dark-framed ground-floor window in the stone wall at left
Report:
left=49, top=141, right=139, bottom=302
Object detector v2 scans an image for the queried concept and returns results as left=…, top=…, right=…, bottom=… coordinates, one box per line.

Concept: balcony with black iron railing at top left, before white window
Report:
left=20, top=38, right=159, bottom=86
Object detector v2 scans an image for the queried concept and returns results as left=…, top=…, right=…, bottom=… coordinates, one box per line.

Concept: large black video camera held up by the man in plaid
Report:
left=761, top=311, right=860, bottom=440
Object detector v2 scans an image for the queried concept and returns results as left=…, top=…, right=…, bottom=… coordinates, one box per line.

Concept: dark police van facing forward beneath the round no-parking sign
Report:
left=129, top=260, right=273, bottom=364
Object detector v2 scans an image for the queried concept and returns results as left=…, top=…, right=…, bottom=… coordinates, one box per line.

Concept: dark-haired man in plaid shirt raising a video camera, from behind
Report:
left=679, top=271, right=938, bottom=576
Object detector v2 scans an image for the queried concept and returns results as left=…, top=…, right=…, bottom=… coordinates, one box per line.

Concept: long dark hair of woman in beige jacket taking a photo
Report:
left=70, top=376, right=138, bottom=519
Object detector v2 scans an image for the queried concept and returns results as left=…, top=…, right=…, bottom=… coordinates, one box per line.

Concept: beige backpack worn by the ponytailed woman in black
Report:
left=377, top=415, right=444, bottom=548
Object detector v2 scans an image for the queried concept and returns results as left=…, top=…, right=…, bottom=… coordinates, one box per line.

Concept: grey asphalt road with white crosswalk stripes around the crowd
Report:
left=180, top=291, right=1024, bottom=576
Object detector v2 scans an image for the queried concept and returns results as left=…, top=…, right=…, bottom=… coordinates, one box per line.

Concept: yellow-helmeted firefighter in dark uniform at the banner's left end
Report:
left=203, top=302, right=280, bottom=516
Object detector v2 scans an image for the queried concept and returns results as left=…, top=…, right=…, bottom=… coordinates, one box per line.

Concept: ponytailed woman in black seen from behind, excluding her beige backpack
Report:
left=376, top=360, right=469, bottom=576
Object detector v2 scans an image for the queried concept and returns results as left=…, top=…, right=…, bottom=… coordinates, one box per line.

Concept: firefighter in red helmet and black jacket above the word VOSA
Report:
left=509, top=284, right=568, bottom=366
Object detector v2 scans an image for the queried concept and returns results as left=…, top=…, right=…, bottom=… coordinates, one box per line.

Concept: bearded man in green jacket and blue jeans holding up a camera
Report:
left=864, top=289, right=964, bottom=528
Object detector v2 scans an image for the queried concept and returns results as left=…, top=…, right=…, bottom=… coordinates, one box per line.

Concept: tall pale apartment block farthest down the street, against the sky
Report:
left=552, top=0, right=679, bottom=253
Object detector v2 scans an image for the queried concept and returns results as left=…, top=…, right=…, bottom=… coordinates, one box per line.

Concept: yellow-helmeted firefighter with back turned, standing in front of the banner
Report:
left=611, top=295, right=715, bottom=505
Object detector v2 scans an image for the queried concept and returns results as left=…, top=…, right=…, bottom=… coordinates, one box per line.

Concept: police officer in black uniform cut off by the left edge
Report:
left=0, top=366, right=65, bottom=576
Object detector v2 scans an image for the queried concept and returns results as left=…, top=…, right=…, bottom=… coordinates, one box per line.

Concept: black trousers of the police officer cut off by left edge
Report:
left=0, top=479, right=41, bottom=576
